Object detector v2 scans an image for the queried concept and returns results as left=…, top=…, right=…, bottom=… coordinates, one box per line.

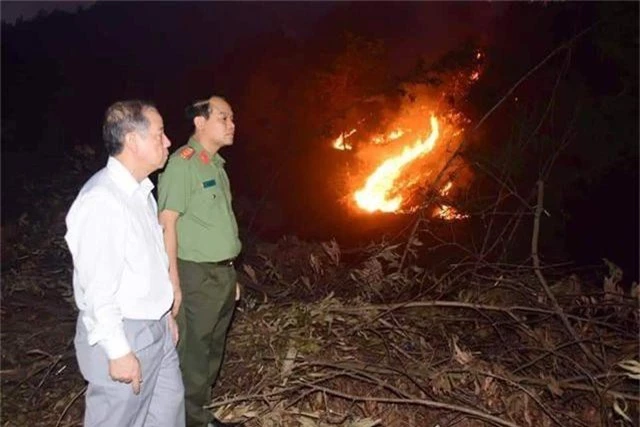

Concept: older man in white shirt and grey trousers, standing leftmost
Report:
left=65, top=101, right=185, bottom=427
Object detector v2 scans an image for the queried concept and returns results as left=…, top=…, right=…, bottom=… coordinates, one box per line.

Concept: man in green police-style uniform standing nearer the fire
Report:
left=158, top=96, right=241, bottom=427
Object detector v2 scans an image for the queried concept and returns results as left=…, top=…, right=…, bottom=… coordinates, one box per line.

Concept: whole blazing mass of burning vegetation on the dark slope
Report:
left=332, top=41, right=483, bottom=219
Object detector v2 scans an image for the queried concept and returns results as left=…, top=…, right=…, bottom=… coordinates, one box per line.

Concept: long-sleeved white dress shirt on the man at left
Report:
left=65, top=157, right=173, bottom=359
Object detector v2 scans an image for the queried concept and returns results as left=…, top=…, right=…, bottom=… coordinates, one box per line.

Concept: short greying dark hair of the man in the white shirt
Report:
left=102, top=99, right=157, bottom=156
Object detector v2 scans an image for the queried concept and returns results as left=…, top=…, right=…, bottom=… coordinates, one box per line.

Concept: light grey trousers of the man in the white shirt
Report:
left=74, top=313, right=185, bottom=427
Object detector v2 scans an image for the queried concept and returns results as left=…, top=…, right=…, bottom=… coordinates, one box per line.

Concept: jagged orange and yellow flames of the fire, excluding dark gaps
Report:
left=340, top=50, right=485, bottom=220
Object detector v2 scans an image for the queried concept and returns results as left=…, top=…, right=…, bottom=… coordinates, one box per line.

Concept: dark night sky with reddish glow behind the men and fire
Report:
left=1, top=1, right=639, bottom=278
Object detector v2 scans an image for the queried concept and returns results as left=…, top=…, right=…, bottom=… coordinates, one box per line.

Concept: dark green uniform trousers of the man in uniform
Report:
left=176, top=259, right=236, bottom=427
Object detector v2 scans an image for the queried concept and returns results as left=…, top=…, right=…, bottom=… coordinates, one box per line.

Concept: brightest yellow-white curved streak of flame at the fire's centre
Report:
left=355, top=116, right=440, bottom=212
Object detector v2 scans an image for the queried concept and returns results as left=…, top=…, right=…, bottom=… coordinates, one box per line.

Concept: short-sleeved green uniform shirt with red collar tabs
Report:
left=158, top=138, right=241, bottom=262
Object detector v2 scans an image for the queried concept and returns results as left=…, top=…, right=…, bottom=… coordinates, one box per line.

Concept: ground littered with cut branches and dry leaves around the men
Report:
left=0, top=226, right=640, bottom=427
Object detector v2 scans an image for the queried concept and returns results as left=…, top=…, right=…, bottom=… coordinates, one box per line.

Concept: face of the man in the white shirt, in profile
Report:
left=136, top=109, right=171, bottom=173
